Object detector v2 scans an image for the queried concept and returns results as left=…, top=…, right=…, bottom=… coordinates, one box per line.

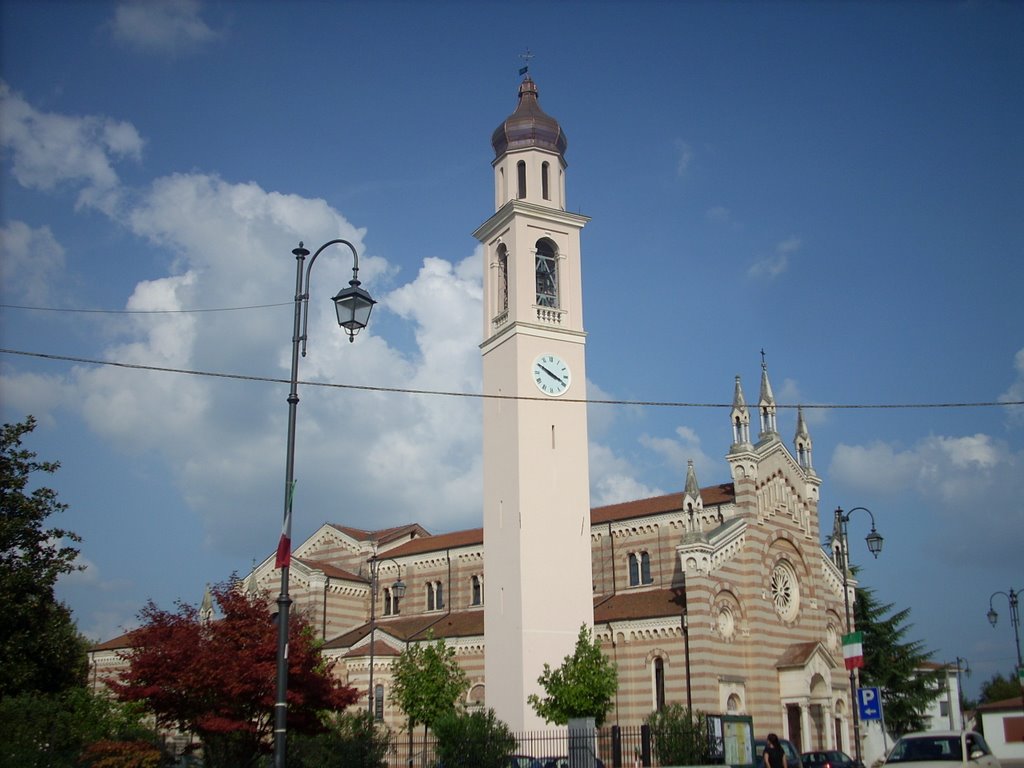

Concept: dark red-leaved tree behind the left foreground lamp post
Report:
left=111, top=581, right=357, bottom=768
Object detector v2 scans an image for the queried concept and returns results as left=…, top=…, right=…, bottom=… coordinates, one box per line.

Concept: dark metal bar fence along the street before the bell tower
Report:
left=388, top=725, right=656, bottom=768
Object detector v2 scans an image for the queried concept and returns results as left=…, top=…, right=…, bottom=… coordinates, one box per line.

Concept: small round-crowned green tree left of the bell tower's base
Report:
left=391, top=634, right=469, bottom=741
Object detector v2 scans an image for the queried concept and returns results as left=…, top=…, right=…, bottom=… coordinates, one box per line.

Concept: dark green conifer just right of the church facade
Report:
left=854, top=588, right=945, bottom=737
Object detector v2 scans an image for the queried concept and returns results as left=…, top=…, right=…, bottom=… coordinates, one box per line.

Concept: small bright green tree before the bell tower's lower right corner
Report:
left=526, top=625, right=618, bottom=726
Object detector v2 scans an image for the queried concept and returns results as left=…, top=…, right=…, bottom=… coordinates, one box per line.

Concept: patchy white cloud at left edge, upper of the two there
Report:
left=0, top=82, right=143, bottom=214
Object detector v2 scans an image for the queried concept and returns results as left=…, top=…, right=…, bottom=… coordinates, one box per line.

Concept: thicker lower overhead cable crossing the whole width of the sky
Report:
left=0, top=348, right=1024, bottom=411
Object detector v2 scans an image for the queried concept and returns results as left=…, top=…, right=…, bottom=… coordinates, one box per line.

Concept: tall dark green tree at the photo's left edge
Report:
left=0, top=416, right=88, bottom=697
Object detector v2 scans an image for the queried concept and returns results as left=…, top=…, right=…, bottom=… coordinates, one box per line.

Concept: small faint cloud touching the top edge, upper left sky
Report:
left=112, top=0, right=218, bottom=53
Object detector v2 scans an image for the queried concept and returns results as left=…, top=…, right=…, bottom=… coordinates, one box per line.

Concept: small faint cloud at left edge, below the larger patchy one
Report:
left=0, top=221, right=65, bottom=305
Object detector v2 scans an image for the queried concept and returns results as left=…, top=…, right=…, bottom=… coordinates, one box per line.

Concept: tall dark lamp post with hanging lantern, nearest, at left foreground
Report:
left=273, top=239, right=377, bottom=768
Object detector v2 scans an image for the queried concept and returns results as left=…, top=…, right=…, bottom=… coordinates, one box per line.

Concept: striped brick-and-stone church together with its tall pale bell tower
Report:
left=94, top=75, right=854, bottom=754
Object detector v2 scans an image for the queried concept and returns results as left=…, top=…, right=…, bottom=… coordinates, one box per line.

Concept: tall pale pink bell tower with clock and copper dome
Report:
left=473, top=75, right=594, bottom=730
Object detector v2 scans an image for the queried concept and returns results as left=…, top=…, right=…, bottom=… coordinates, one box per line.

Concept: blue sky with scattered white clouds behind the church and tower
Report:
left=0, top=0, right=1024, bottom=693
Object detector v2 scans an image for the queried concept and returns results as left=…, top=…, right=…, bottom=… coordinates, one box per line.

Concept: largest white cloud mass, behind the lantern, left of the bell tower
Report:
left=25, top=160, right=482, bottom=556
